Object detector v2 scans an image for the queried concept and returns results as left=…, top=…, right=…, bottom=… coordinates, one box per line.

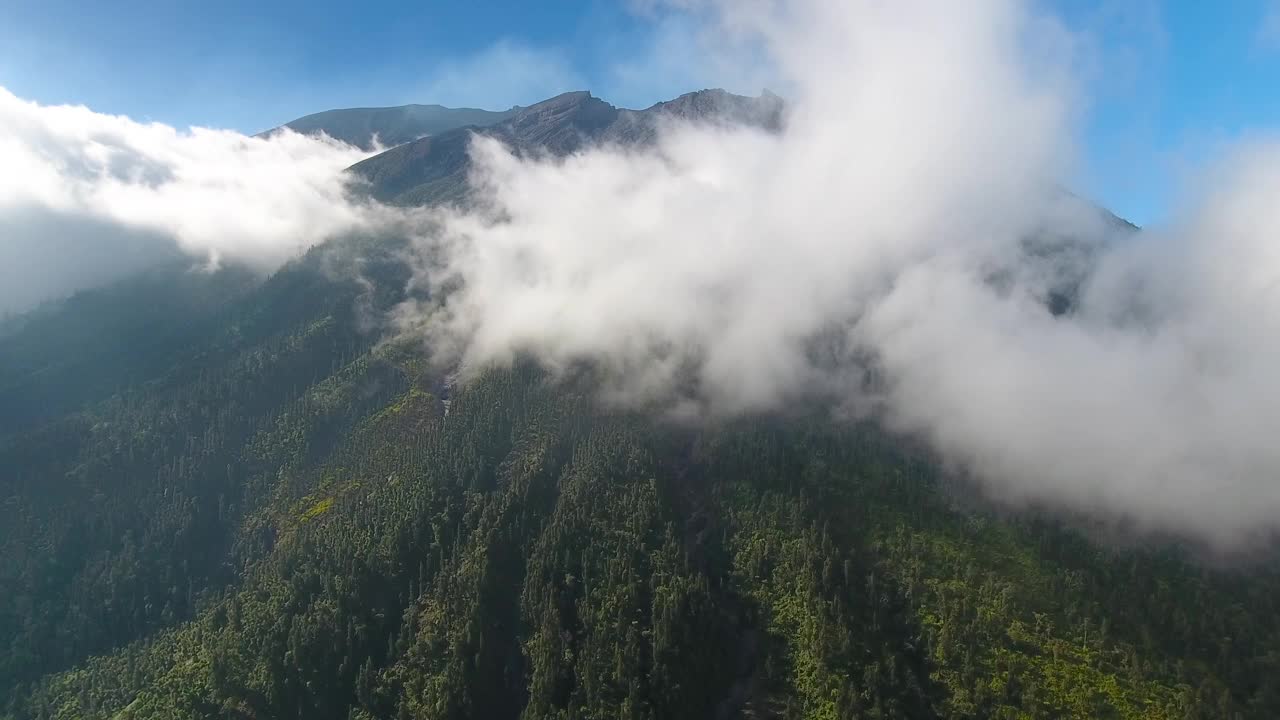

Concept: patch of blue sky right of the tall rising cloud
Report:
left=1057, top=0, right=1280, bottom=224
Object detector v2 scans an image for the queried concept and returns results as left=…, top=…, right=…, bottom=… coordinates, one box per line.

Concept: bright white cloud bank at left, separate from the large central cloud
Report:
left=0, top=88, right=367, bottom=311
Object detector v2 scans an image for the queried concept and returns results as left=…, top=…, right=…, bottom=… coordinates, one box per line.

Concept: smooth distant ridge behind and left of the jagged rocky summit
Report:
left=261, top=105, right=520, bottom=150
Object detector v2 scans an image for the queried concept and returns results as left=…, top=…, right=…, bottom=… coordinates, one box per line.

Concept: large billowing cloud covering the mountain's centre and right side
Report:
left=402, top=0, right=1280, bottom=547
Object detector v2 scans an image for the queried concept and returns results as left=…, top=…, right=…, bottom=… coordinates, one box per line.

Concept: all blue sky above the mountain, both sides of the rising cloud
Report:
left=0, top=0, right=1280, bottom=224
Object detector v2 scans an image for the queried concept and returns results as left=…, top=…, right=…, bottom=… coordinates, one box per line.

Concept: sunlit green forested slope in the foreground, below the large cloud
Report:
left=15, top=358, right=1280, bottom=719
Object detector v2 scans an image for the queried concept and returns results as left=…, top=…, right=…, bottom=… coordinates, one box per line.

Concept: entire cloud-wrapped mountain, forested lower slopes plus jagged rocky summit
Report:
left=0, top=92, right=1280, bottom=720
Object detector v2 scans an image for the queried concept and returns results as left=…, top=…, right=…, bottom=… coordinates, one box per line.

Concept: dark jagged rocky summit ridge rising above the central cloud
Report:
left=351, top=90, right=783, bottom=205
